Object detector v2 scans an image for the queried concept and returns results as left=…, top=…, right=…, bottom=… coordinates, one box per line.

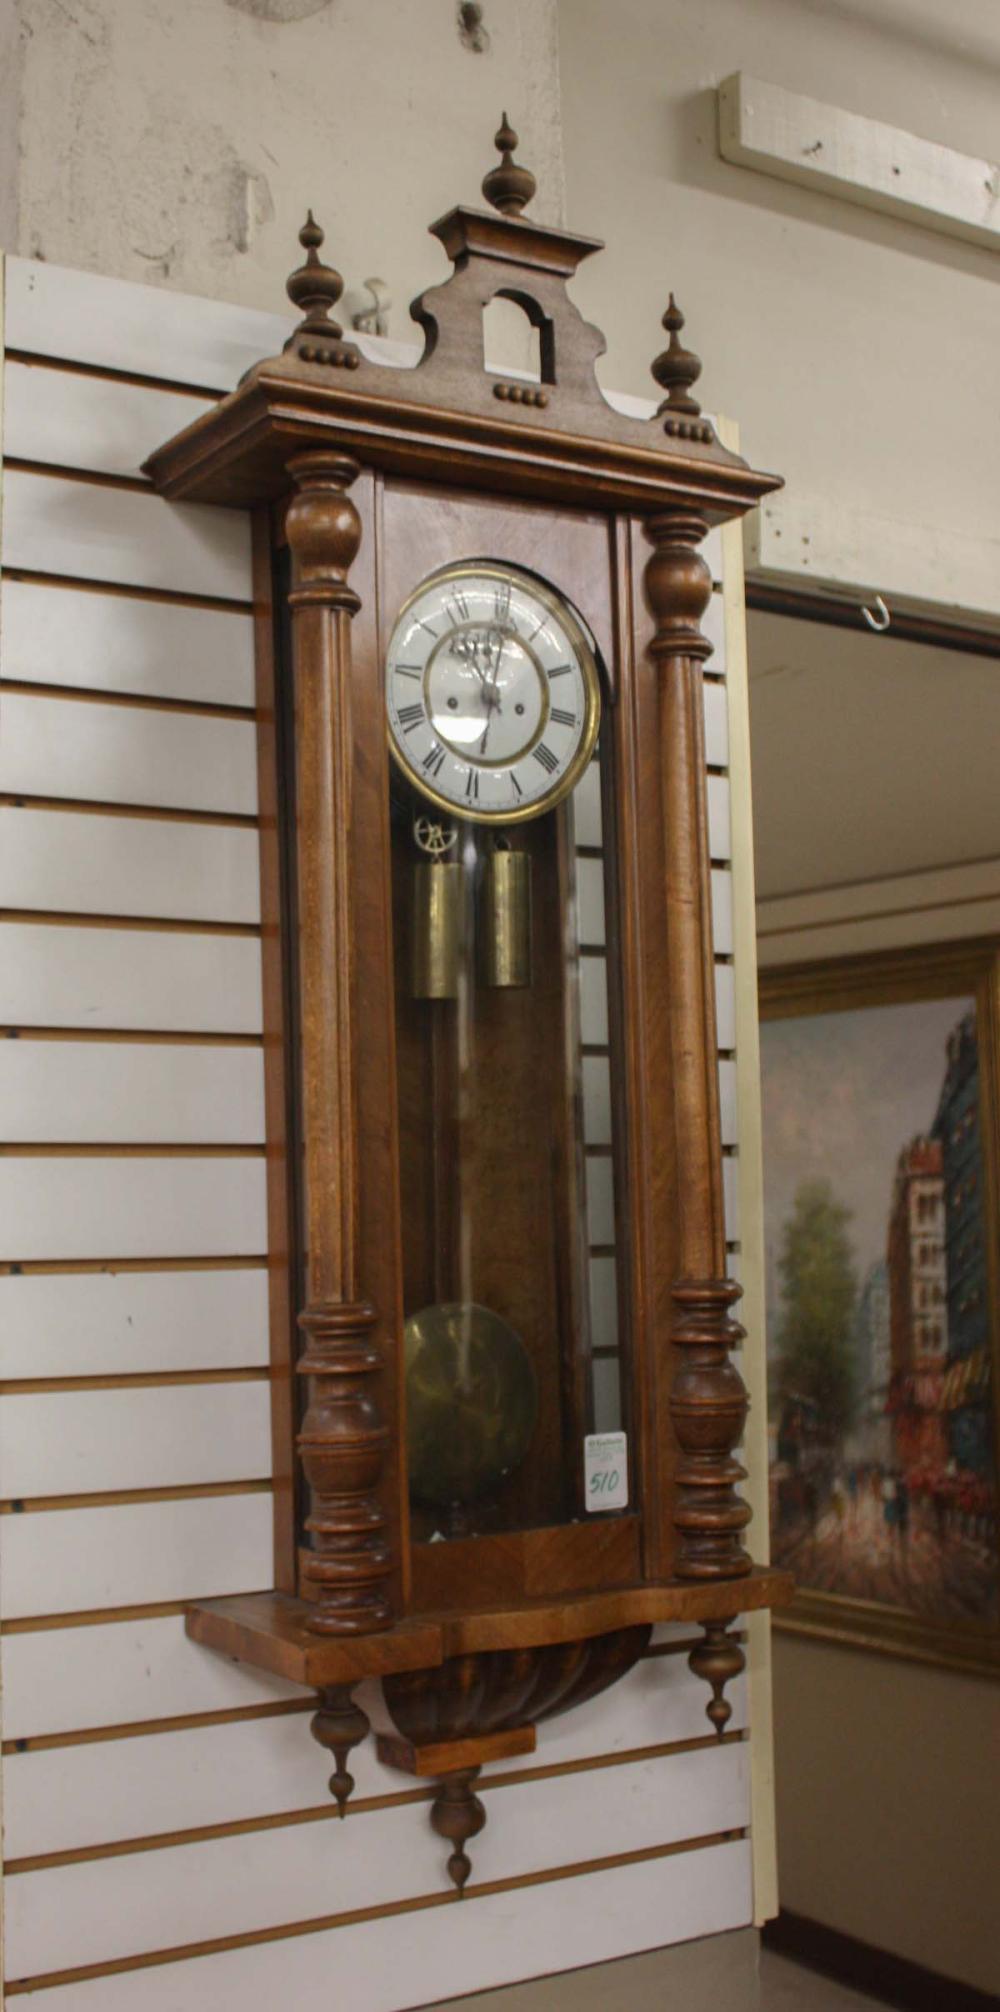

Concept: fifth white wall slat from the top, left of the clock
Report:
left=0, top=692, right=258, bottom=817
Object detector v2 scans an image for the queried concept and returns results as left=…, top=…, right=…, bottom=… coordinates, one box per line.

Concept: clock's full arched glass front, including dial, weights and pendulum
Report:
left=384, top=561, right=628, bottom=1543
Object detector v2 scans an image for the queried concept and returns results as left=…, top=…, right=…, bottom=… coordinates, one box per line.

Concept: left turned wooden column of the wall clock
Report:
left=288, top=449, right=392, bottom=1633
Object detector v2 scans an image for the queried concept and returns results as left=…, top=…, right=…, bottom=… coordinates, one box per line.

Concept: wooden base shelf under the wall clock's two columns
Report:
left=187, top=1567, right=793, bottom=1690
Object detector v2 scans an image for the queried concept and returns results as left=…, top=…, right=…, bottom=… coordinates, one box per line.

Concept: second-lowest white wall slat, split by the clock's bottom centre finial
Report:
left=6, top=1728, right=748, bottom=1976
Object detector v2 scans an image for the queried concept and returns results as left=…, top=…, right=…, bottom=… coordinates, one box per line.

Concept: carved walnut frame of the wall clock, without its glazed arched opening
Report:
left=147, top=129, right=789, bottom=1889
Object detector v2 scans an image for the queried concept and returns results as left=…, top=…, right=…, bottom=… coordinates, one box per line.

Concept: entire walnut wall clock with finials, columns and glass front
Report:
left=147, top=121, right=789, bottom=1893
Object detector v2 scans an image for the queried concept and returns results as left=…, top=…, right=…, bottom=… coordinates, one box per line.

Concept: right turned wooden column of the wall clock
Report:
left=646, top=494, right=751, bottom=1579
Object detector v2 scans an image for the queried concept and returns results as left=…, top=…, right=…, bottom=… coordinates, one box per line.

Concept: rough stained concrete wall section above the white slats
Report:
left=0, top=0, right=563, bottom=334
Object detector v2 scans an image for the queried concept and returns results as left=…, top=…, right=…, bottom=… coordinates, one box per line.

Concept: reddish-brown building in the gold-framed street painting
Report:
left=885, top=1137, right=948, bottom=1475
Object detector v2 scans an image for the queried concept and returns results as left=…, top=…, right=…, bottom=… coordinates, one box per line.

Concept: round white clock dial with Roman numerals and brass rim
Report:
left=386, top=559, right=600, bottom=823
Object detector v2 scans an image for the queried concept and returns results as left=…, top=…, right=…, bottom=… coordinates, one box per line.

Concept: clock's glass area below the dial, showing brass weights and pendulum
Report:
left=390, top=608, right=626, bottom=1541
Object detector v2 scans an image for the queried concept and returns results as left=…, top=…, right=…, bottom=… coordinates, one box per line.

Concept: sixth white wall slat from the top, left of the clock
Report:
left=0, top=807, right=260, bottom=921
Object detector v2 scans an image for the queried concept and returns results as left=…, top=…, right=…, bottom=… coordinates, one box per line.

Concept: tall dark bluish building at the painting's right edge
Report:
left=934, top=1008, right=994, bottom=1479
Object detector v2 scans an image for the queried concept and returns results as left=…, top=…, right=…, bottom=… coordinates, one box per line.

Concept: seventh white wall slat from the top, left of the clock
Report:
left=0, top=921, right=262, bottom=1034
